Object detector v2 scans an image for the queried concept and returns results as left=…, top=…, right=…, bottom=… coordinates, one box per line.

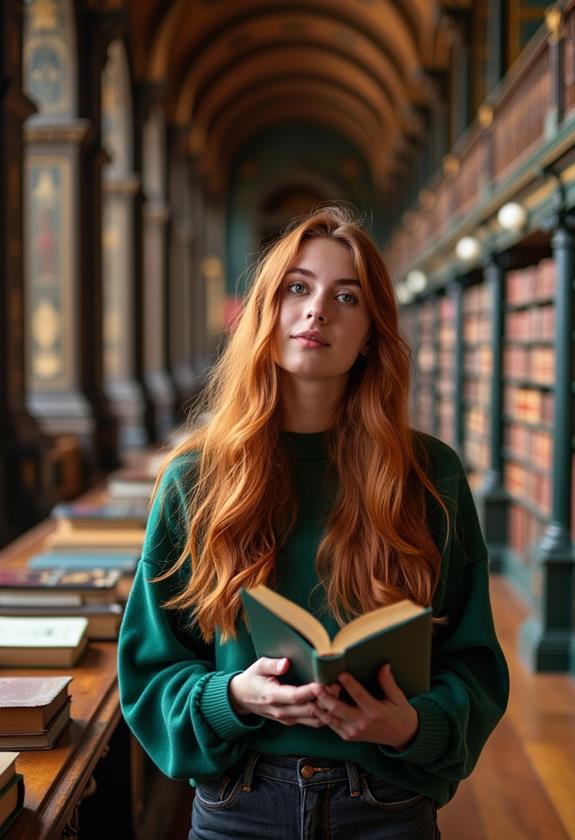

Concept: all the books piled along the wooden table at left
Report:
left=0, top=434, right=188, bottom=835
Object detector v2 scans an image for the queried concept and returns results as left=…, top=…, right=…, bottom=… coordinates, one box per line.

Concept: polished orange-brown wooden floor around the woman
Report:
left=170, top=577, right=575, bottom=840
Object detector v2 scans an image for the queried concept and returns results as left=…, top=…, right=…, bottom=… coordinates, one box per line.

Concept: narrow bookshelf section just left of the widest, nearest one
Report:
left=463, top=283, right=492, bottom=490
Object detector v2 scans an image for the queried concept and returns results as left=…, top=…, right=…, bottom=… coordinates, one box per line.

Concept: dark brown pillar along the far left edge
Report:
left=0, top=0, right=52, bottom=545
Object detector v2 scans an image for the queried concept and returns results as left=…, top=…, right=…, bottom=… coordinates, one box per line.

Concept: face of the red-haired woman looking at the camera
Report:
left=274, top=237, right=371, bottom=388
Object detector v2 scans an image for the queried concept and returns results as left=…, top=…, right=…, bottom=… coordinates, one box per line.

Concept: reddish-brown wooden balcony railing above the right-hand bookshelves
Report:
left=386, top=0, right=575, bottom=276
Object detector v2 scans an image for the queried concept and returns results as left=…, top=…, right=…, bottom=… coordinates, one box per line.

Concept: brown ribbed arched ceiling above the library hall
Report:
left=128, top=0, right=445, bottom=189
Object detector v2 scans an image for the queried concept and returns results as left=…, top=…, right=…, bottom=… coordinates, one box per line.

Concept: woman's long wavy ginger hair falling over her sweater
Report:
left=156, top=207, right=448, bottom=641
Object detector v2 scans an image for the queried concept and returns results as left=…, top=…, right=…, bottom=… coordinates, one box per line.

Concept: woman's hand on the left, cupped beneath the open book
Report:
left=229, top=656, right=341, bottom=728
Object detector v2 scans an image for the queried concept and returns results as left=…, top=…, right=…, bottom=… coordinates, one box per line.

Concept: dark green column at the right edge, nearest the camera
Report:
left=519, top=214, right=575, bottom=671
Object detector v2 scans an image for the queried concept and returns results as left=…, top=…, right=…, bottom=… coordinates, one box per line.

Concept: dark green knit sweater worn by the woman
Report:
left=119, top=432, right=509, bottom=805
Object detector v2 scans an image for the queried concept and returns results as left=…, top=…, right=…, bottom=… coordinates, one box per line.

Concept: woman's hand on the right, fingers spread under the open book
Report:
left=315, top=664, right=419, bottom=750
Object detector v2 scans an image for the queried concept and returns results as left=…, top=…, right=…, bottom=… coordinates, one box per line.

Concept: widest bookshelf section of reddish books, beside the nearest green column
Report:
left=503, top=259, right=555, bottom=592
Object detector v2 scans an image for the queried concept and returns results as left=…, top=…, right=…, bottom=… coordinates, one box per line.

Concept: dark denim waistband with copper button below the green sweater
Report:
left=242, top=752, right=366, bottom=796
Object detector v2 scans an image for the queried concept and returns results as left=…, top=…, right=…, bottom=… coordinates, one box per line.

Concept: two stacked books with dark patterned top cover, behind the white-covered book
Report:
left=0, top=568, right=123, bottom=639
